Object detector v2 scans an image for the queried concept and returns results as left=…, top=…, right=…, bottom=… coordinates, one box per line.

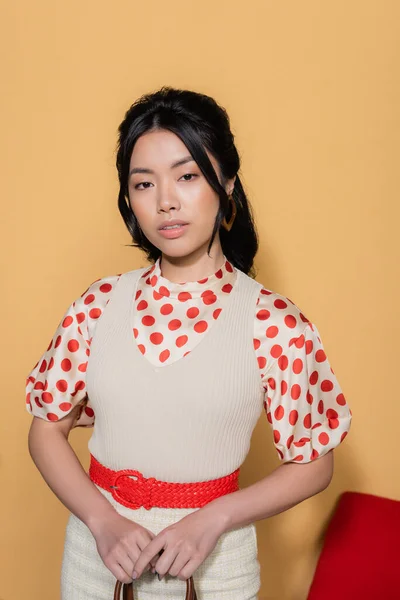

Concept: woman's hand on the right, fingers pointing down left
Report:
left=134, top=509, right=223, bottom=580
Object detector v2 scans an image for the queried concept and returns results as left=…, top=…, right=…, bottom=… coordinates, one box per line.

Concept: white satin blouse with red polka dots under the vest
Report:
left=26, top=258, right=351, bottom=462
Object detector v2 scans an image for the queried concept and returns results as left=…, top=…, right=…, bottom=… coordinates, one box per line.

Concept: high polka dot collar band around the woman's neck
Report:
left=143, top=256, right=236, bottom=299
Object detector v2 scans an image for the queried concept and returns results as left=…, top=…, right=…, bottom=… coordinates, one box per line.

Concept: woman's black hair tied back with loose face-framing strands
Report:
left=116, top=86, right=258, bottom=277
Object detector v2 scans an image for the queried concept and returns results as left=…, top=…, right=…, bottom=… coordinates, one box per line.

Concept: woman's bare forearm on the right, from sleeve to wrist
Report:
left=201, top=450, right=333, bottom=532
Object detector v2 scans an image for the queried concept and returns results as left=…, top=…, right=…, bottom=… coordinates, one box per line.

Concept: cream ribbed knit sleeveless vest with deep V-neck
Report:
left=87, top=269, right=265, bottom=482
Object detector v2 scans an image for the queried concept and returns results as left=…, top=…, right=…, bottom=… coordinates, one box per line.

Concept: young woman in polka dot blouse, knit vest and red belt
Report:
left=27, top=87, right=351, bottom=600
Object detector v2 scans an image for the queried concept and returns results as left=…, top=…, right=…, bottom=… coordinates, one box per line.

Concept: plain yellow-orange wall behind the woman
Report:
left=0, top=0, right=400, bottom=600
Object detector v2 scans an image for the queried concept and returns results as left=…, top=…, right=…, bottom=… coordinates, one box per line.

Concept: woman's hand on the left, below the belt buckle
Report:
left=91, top=512, right=158, bottom=583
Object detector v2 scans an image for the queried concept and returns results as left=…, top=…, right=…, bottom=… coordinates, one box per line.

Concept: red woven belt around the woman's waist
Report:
left=89, top=455, right=240, bottom=510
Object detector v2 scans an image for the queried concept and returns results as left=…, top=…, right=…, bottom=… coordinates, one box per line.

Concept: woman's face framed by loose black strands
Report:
left=128, top=130, right=234, bottom=258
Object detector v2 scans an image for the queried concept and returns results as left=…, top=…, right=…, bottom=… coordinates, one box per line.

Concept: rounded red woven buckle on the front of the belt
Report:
left=110, top=469, right=155, bottom=510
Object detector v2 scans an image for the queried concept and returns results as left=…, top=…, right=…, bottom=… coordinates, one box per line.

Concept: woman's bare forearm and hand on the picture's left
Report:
left=28, top=406, right=155, bottom=583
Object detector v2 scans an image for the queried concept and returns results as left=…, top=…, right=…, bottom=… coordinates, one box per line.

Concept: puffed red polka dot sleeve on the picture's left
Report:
left=26, top=276, right=118, bottom=427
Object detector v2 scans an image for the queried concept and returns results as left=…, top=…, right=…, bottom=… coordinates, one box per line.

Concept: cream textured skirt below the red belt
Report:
left=61, top=488, right=260, bottom=600
